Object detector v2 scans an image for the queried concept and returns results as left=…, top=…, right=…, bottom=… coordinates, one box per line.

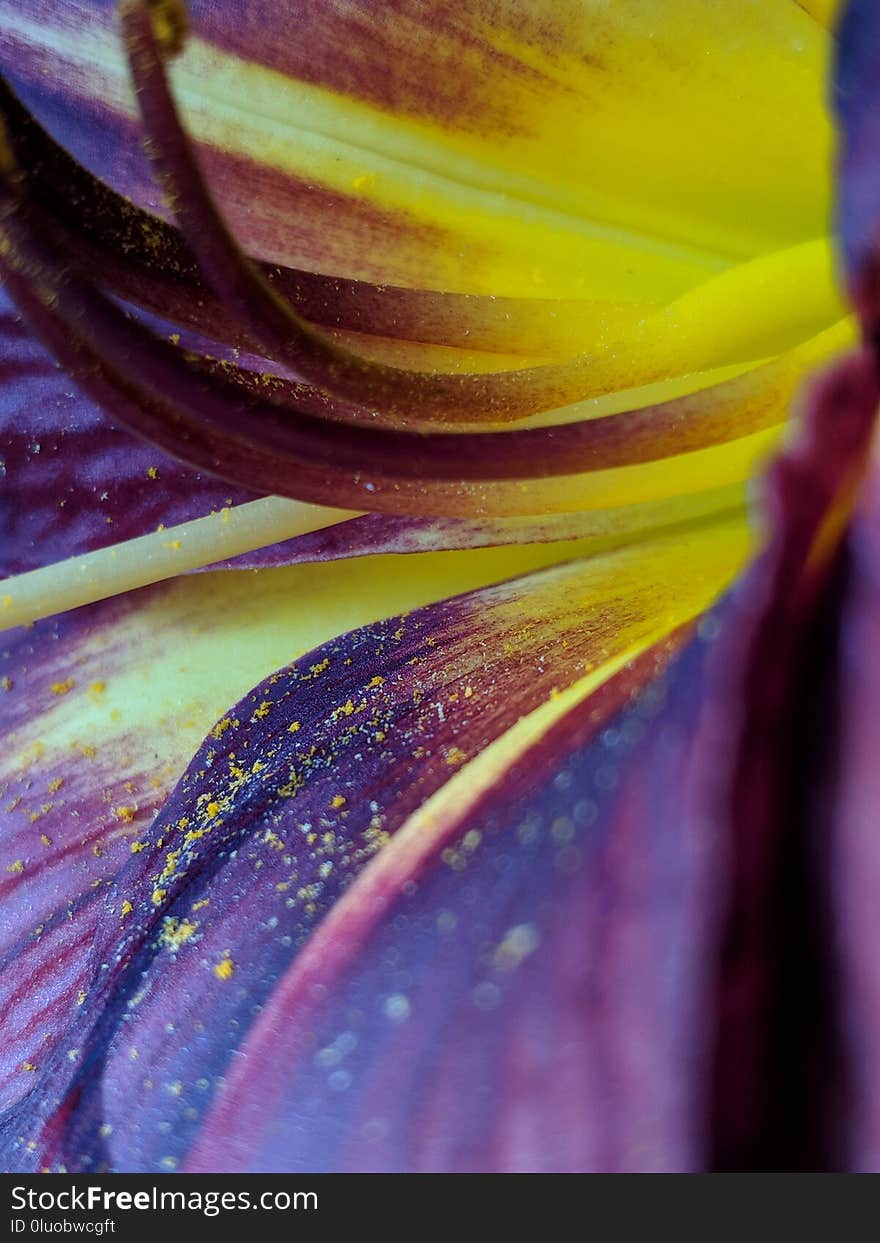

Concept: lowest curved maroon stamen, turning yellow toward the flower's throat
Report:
left=0, top=122, right=840, bottom=516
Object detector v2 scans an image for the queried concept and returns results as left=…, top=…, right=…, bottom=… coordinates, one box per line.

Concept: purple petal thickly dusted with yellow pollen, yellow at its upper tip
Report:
left=0, top=509, right=742, bottom=1170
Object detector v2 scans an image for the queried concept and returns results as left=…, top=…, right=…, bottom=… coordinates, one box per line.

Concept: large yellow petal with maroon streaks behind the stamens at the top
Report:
left=2, top=0, right=830, bottom=300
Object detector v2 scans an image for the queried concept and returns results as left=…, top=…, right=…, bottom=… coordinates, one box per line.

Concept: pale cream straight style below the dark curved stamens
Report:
left=0, top=496, right=359, bottom=630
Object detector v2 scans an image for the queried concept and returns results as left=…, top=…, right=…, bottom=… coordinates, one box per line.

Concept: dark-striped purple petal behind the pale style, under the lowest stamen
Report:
left=0, top=277, right=740, bottom=576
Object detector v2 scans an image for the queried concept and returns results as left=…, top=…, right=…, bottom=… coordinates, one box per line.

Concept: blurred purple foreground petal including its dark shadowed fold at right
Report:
left=188, top=351, right=880, bottom=1171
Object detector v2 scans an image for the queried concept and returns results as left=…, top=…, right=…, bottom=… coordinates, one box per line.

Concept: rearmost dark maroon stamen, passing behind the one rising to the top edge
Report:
left=0, top=76, right=591, bottom=354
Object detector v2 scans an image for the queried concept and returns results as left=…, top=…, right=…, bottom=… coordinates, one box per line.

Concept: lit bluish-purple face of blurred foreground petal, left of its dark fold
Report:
left=180, top=641, right=723, bottom=1172
